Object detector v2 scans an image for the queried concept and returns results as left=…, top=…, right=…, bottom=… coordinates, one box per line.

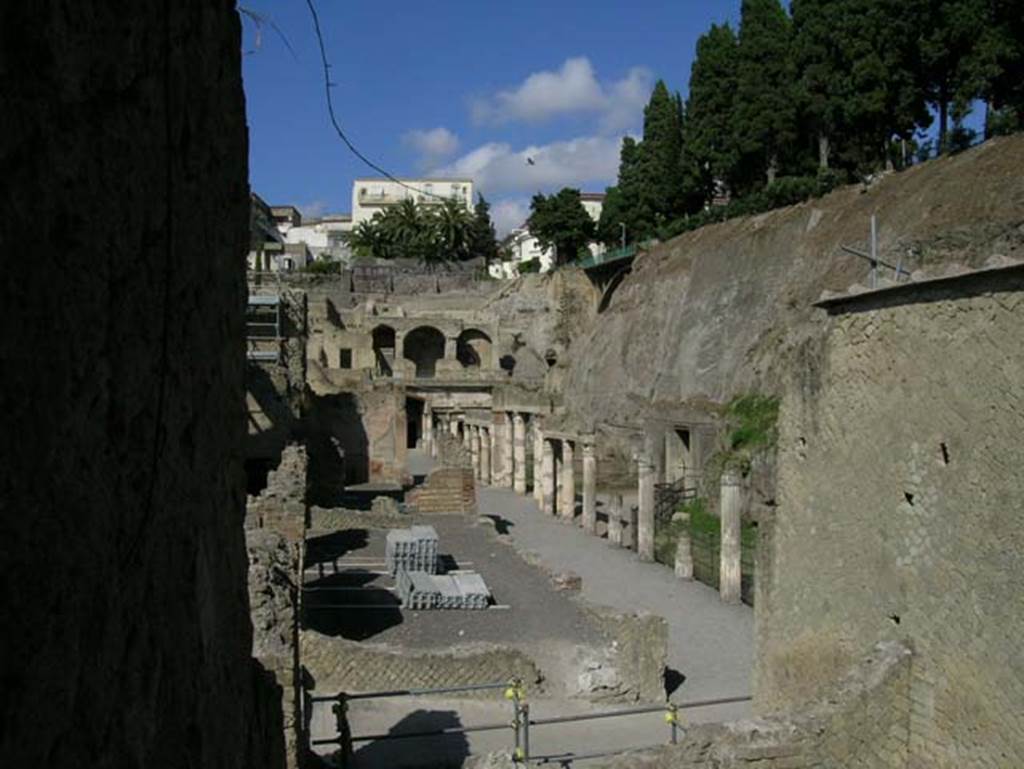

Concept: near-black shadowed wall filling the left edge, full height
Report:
left=0, top=0, right=284, bottom=769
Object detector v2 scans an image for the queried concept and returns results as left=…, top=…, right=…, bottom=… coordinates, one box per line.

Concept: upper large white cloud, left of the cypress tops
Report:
left=472, top=56, right=652, bottom=132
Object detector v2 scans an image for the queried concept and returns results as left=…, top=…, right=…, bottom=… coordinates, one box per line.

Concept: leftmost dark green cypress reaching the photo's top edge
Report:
left=732, top=0, right=798, bottom=186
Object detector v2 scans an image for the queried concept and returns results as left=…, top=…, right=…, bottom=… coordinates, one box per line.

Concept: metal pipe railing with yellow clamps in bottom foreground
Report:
left=305, top=678, right=751, bottom=769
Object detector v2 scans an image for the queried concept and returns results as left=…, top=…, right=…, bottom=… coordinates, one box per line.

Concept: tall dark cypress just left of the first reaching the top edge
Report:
left=683, top=25, right=737, bottom=202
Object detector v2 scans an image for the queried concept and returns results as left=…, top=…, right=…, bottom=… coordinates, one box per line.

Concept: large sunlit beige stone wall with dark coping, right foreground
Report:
left=756, top=267, right=1024, bottom=769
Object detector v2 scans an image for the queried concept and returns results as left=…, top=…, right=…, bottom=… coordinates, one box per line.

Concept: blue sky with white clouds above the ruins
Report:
left=241, top=0, right=739, bottom=230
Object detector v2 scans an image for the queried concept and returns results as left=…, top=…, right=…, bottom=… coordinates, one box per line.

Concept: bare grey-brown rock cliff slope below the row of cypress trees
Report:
left=564, top=136, right=1024, bottom=425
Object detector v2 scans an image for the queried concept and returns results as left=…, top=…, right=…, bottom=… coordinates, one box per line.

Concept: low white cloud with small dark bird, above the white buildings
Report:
left=432, top=136, right=621, bottom=197
